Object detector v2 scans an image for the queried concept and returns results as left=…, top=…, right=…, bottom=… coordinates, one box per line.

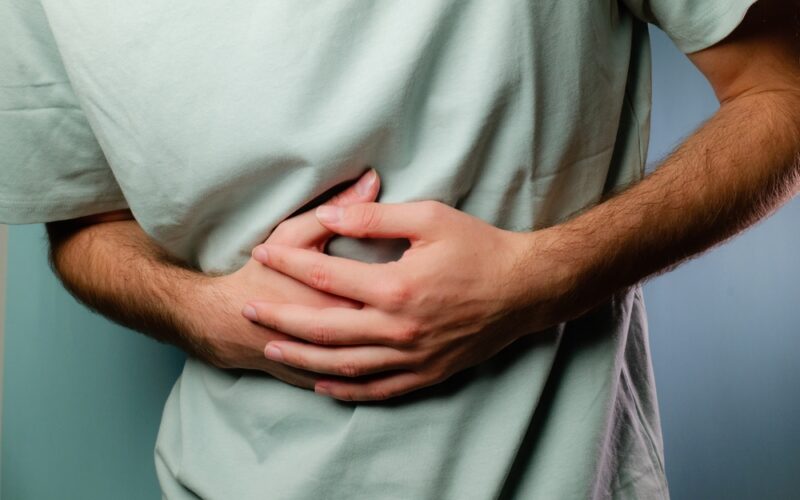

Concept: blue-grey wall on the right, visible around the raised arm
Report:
left=644, top=26, right=800, bottom=500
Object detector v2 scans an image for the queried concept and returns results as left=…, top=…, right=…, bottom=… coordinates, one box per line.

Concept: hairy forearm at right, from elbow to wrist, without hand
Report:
left=530, top=90, right=800, bottom=310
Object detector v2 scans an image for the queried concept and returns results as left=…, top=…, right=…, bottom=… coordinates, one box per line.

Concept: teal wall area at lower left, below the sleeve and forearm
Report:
left=2, top=225, right=183, bottom=500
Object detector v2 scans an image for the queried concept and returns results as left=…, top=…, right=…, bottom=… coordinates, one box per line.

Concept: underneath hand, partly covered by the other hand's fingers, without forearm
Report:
left=193, top=169, right=380, bottom=389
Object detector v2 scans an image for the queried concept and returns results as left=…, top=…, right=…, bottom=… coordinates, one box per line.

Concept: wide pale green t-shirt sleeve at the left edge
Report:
left=0, top=0, right=128, bottom=224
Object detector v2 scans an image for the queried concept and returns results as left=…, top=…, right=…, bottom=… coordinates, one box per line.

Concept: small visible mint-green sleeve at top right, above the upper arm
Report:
left=624, top=0, right=756, bottom=54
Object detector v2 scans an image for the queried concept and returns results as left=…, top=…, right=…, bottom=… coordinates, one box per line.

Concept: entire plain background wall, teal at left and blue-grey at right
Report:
left=0, top=28, right=800, bottom=500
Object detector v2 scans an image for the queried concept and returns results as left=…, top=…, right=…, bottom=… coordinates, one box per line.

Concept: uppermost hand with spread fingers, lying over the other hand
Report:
left=244, top=201, right=568, bottom=401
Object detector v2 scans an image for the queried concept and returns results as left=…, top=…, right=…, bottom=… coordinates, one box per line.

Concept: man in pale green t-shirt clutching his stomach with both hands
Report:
left=0, top=0, right=800, bottom=499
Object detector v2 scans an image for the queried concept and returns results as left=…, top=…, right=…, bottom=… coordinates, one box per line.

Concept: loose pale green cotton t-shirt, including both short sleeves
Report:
left=0, top=0, right=754, bottom=500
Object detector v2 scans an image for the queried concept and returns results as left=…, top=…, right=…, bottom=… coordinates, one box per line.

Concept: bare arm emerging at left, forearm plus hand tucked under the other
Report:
left=47, top=169, right=380, bottom=389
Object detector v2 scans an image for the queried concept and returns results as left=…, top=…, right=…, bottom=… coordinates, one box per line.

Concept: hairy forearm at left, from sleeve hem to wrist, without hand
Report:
left=47, top=220, right=220, bottom=361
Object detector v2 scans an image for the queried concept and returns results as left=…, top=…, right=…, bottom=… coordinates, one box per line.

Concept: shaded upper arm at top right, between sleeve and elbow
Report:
left=689, top=0, right=800, bottom=103
